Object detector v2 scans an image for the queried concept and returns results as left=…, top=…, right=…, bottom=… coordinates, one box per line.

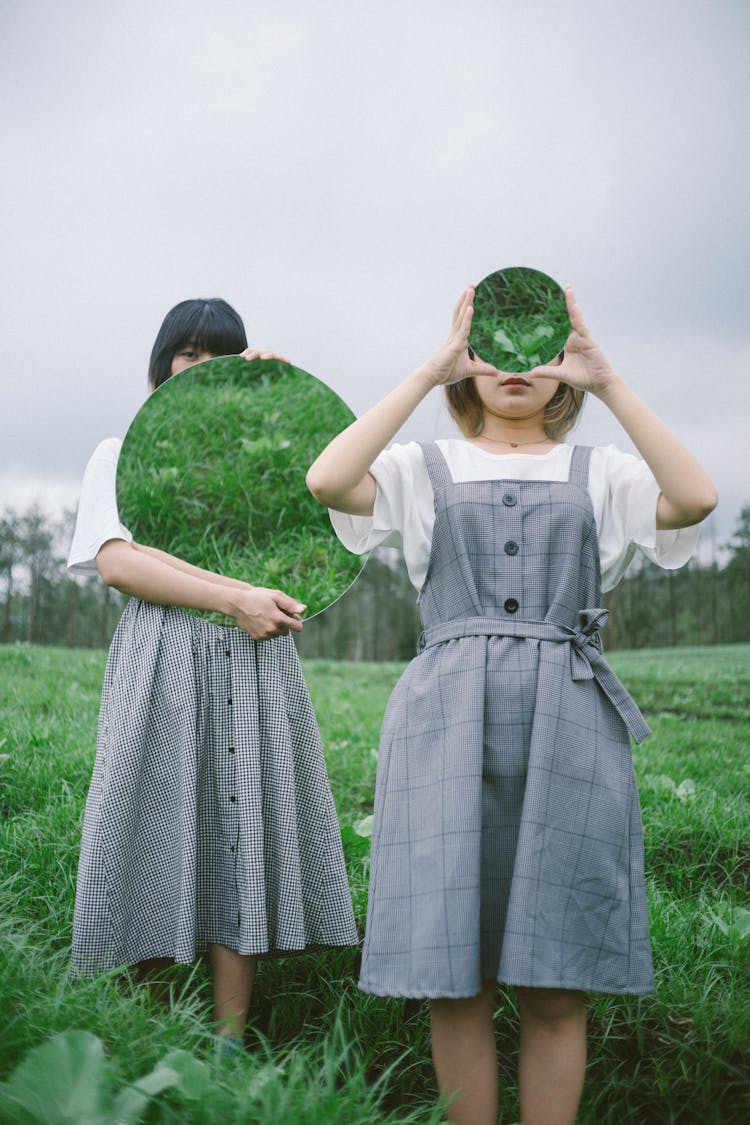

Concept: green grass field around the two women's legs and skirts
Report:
left=0, top=646, right=750, bottom=1125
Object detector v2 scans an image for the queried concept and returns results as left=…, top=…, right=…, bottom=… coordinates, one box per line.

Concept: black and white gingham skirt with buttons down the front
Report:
left=72, top=599, right=358, bottom=975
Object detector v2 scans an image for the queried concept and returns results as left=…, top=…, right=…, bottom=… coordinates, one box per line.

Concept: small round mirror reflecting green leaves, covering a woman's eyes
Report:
left=469, top=266, right=570, bottom=374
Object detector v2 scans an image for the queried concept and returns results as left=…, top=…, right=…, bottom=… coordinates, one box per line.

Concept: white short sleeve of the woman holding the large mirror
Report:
left=67, top=438, right=133, bottom=575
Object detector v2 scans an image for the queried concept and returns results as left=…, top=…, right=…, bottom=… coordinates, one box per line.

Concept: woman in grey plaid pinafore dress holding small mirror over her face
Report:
left=308, top=286, right=716, bottom=1125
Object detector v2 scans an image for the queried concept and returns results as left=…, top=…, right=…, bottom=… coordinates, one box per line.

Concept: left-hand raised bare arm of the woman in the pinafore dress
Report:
left=307, top=286, right=497, bottom=515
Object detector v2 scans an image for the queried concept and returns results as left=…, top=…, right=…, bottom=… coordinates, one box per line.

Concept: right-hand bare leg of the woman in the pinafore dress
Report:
left=516, top=988, right=586, bottom=1125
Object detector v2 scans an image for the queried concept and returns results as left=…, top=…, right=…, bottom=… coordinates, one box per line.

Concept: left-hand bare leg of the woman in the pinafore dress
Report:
left=430, top=981, right=497, bottom=1125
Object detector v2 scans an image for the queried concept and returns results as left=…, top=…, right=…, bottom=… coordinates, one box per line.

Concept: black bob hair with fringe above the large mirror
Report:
left=148, top=297, right=247, bottom=390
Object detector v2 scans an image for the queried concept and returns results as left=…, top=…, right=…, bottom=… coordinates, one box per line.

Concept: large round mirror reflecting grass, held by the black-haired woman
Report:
left=117, top=356, right=363, bottom=624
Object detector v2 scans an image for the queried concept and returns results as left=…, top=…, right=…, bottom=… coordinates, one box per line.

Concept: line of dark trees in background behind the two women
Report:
left=0, top=505, right=750, bottom=660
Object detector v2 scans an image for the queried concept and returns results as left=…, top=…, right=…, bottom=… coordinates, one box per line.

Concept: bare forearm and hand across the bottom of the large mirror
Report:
left=97, top=539, right=305, bottom=640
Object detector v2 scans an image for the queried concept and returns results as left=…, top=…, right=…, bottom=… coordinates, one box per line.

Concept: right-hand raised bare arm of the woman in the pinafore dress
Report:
left=531, top=286, right=717, bottom=531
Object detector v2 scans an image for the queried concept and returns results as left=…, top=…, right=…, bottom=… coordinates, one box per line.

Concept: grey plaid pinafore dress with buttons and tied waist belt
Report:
left=360, top=444, right=653, bottom=997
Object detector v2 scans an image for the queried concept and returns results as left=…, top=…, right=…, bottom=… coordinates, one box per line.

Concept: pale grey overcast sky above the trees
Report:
left=0, top=0, right=750, bottom=538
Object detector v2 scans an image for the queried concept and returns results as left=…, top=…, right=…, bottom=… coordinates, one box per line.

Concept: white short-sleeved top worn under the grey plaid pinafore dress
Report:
left=331, top=438, right=698, bottom=591
